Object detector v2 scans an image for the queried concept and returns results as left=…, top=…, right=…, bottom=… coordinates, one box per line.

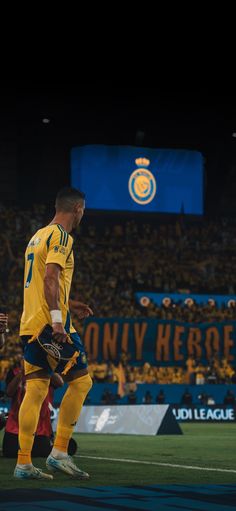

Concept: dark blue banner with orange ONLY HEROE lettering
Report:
left=83, top=318, right=236, bottom=366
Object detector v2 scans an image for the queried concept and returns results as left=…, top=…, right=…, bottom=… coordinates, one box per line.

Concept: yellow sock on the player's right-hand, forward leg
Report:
left=52, top=374, right=92, bottom=455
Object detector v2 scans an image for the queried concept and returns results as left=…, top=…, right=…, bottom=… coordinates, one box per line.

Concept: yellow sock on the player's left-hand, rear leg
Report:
left=17, top=379, right=49, bottom=465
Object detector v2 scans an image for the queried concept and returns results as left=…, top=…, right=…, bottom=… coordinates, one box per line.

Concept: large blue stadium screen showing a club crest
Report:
left=71, top=145, right=203, bottom=215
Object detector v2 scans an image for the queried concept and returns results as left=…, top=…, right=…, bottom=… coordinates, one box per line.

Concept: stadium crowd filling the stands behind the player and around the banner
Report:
left=0, top=204, right=236, bottom=383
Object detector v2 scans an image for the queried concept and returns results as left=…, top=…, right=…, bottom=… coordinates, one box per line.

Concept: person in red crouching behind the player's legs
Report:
left=2, top=354, right=64, bottom=458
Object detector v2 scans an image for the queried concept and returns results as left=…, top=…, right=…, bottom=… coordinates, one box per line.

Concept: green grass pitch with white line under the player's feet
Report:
left=0, top=423, right=236, bottom=489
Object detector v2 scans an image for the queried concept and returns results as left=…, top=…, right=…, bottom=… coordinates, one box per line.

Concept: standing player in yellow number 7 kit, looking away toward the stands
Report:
left=14, top=188, right=93, bottom=479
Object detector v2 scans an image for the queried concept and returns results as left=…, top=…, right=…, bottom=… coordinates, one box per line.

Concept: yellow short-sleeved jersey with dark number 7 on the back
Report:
left=20, top=224, right=75, bottom=335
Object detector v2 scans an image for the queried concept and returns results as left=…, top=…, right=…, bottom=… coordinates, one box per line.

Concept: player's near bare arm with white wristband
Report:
left=44, top=263, right=67, bottom=342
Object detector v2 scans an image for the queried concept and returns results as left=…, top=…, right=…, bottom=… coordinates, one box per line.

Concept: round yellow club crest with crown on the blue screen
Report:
left=128, top=158, right=156, bottom=204
